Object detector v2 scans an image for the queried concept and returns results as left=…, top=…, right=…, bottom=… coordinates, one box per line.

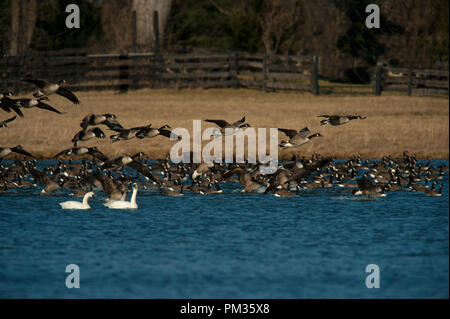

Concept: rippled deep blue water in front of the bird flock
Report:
left=0, top=161, right=449, bottom=298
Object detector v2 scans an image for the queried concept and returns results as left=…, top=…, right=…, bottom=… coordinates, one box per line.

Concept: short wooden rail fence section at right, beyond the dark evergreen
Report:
left=380, top=66, right=449, bottom=96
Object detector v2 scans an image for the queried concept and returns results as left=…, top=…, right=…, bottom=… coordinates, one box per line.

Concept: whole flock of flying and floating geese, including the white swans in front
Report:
left=0, top=79, right=448, bottom=209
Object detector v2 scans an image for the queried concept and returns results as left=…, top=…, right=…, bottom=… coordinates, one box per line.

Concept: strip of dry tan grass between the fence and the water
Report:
left=0, top=89, right=449, bottom=159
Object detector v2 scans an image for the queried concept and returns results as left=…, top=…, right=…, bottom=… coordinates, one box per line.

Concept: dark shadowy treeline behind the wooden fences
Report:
left=0, top=0, right=449, bottom=82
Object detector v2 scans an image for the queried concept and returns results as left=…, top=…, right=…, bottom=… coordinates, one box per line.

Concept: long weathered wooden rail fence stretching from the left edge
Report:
left=0, top=52, right=317, bottom=94
